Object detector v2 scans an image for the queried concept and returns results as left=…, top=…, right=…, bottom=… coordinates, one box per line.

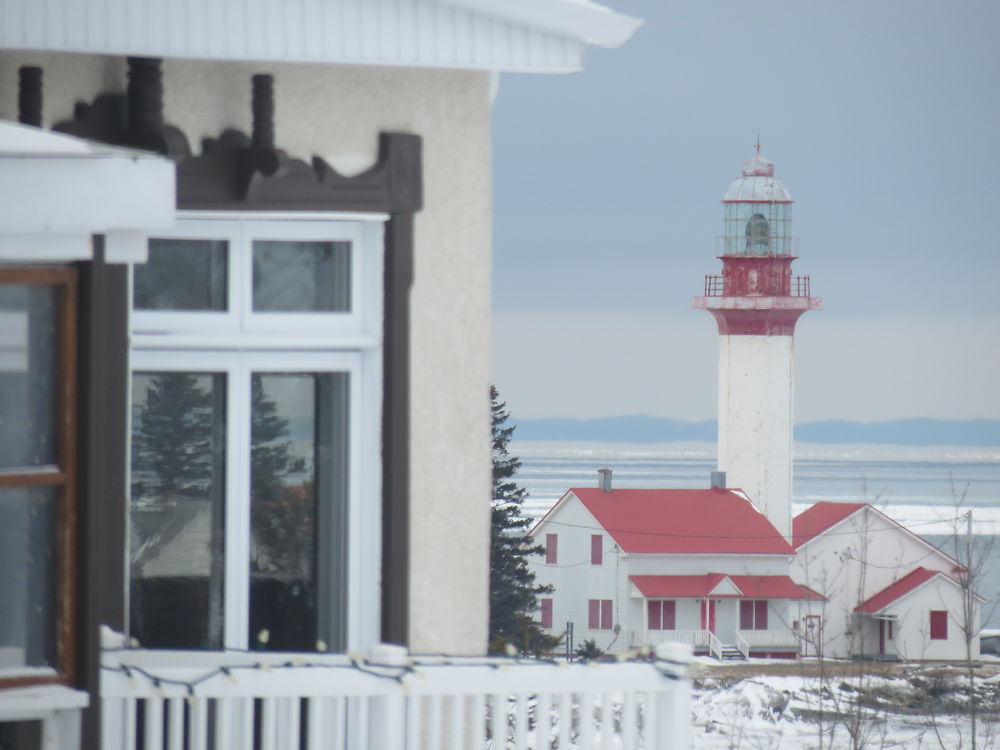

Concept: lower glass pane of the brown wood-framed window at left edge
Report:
left=0, top=487, right=58, bottom=677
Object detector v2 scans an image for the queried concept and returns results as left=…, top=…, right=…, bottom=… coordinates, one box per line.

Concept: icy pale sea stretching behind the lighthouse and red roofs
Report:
left=509, top=439, right=1000, bottom=627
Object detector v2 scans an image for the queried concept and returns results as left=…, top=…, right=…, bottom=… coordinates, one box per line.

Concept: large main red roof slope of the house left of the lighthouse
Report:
left=570, top=487, right=794, bottom=555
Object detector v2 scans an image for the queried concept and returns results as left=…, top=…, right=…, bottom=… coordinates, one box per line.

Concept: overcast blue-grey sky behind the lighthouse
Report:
left=493, top=0, right=1000, bottom=421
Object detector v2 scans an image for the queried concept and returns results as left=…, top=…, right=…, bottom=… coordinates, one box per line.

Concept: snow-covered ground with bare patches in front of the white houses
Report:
left=693, top=659, right=1000, bottom=750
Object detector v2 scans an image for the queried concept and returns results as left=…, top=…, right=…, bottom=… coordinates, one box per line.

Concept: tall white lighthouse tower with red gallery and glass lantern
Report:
left=694, top=148, right=821, bottom=539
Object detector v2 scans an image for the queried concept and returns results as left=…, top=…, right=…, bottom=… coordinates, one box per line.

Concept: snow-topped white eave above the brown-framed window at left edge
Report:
left=0, top=121, right=175, bottom=262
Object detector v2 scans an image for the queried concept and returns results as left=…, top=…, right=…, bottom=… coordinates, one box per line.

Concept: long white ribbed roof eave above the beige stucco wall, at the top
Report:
left=0, top=0, right=641, bottom=73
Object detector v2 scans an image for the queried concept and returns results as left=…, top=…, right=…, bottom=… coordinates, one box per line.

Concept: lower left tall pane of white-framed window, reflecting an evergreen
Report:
left=130, top=372, right=226, bottom=648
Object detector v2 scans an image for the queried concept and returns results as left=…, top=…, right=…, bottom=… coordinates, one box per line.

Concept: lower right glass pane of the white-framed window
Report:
left=249, top=373, right=348, bottom=651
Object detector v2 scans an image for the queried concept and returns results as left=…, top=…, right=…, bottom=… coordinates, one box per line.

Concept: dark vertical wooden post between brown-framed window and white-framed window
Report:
left=77, top=244, right=129, bottom=748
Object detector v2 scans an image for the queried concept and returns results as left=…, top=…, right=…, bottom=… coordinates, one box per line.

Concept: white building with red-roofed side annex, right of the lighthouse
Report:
left=792, top=502, right=984, bottom=659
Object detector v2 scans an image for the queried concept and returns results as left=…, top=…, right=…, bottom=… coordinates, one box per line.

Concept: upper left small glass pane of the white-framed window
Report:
left=133, top=239, right=228, bottom=311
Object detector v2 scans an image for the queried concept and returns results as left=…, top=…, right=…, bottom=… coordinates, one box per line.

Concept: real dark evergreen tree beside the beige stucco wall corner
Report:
left=490, top=386, right=559, bottom=654
